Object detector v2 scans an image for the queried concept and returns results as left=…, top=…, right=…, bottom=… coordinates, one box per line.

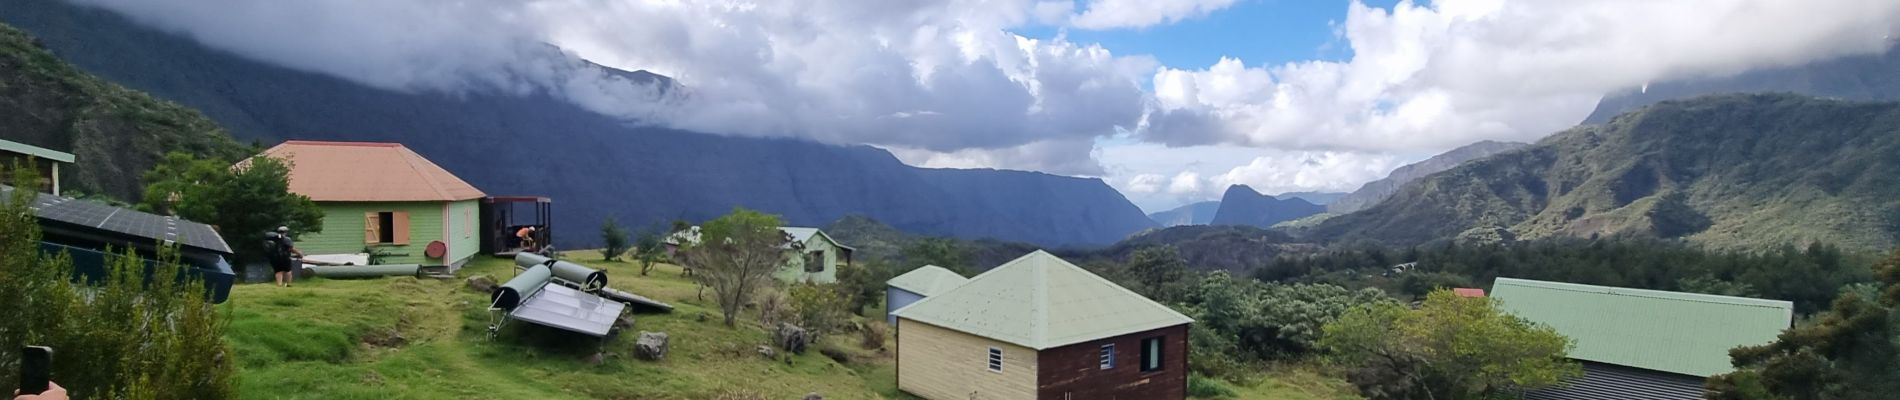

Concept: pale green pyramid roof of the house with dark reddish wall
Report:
left=895, top=250, right=1193, bottom=351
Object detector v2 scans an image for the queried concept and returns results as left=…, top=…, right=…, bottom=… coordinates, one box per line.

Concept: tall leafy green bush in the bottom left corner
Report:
left=0, top=165, right=238, bottom=400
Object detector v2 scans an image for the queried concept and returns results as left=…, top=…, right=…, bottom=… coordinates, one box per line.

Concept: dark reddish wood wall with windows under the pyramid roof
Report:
left=1036, top=324, right=1188, bottom=400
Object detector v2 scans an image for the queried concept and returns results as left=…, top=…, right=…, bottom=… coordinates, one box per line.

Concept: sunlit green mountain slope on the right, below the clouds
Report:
left=1307, top=95, right=1900, bottom=250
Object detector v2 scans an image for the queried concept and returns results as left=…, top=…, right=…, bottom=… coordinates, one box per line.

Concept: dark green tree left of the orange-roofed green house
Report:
left=139, top=152, right=323, bottom=260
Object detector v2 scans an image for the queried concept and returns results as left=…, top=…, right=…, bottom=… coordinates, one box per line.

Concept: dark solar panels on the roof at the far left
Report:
left=0, top=186, right=232, bottom=254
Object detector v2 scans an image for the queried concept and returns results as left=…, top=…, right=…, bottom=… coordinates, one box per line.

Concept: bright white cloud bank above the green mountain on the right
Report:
left=1142, top=0, right=1900, bottom=152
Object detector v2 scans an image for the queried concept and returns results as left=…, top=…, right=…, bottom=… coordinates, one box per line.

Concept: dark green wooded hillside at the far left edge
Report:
left=0, top=25, right=251, bottom=201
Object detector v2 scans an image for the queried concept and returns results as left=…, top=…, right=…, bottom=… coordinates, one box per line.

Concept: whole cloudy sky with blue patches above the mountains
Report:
left=70, top=0, right=1900, bottom=212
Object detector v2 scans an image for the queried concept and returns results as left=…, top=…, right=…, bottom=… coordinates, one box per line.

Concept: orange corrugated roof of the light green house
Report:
left=248, top=140, right=485, bottom=201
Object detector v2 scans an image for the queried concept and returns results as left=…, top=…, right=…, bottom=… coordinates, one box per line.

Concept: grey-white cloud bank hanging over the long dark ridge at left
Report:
left=76, top=0, right=1155, bottom=163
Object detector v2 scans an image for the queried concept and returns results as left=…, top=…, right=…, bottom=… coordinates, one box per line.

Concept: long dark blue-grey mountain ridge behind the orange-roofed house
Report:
left=0, top=0, right=1153, bottom=246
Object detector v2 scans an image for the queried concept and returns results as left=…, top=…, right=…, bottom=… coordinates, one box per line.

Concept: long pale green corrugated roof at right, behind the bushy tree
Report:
left=1492, top=279, right=1794, bottom=377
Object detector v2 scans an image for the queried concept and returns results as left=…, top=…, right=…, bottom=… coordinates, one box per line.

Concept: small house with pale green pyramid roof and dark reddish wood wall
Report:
left=893, top=250, right=1193, bottom=400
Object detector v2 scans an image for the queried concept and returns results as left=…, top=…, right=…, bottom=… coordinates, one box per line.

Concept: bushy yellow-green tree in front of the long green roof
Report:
left=1321, top=290, right=1581, bottom=400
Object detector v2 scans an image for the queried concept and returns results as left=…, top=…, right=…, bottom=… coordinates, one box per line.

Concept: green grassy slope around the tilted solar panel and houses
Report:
left=228, top=254, right=1341, bottom=400
